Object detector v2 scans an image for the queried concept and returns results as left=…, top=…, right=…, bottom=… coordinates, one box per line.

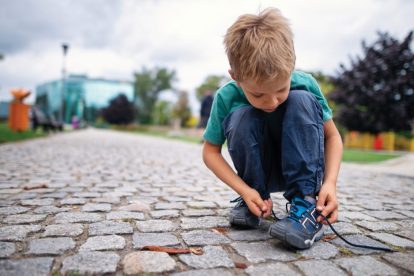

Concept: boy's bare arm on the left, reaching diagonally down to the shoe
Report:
left=203, top=141, right=270, bottom=217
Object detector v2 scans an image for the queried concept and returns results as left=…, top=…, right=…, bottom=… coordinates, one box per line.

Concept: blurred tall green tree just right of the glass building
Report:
left=134, top=68, right=176, bottom=124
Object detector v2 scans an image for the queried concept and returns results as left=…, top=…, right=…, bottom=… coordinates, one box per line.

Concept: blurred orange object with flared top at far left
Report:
left=9, top=89, right=30, bottom=131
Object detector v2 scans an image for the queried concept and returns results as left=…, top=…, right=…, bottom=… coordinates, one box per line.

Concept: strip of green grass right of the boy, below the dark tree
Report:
left=342, top=149, right=401, bottom=163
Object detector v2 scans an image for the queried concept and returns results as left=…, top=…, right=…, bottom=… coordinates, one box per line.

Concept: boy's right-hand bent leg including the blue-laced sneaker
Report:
left=269, top=91, right=324, bottom=249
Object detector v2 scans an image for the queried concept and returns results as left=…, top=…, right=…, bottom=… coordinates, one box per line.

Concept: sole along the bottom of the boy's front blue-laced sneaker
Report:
left=269, top=225, right=324, bottom=249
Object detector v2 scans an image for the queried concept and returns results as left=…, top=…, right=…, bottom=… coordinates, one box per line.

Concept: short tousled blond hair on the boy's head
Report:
left=224, top=8, right=296, bottom=83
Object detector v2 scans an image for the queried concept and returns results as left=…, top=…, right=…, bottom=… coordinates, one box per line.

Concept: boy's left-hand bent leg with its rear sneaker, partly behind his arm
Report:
left=223, top=106, right=270, bottom=228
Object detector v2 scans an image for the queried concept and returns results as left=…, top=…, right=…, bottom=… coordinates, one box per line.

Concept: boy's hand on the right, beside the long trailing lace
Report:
left=316, top=183, right=338, bottom=224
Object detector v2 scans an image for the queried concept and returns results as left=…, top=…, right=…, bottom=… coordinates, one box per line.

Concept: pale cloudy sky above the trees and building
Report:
left=0, top=0, right=414, bottom=109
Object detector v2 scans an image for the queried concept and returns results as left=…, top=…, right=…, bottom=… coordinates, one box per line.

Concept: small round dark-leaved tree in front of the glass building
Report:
left=102, top=94, right=135, bottom=125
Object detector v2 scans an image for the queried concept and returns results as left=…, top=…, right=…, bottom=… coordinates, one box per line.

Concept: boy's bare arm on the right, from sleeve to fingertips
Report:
left=317, top=119, right=342, bottom=224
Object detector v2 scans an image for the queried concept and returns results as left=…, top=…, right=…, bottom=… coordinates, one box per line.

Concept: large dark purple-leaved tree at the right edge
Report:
left=329, top=32, right=414, bottom=133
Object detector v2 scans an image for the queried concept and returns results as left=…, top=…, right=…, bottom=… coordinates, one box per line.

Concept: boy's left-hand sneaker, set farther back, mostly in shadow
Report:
left=229, top=197, right=260, bottom=228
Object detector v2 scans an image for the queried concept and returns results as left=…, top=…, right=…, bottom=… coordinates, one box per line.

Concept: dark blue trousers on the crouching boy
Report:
left=222, top=90, right=325, bottom=201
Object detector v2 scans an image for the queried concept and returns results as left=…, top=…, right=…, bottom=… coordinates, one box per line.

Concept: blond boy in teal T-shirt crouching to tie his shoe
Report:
left=203, top=8, right=342, bottom=248
